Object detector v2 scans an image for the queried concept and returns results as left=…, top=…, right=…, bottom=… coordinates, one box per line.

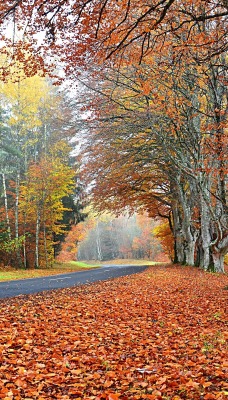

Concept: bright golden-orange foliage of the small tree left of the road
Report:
left=20, top=158, right=75, bottom=234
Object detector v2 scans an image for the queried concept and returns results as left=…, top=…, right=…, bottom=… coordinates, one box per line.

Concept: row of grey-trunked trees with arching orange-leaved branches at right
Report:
left=78, top=37, right=228, bottom=272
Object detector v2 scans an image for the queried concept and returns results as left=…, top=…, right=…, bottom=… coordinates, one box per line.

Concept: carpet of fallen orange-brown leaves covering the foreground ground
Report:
left=0, top=266, right=228, bottom=400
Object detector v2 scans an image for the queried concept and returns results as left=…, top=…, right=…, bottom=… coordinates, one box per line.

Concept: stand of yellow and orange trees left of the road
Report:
left=0, top=69, right=84, bottom=268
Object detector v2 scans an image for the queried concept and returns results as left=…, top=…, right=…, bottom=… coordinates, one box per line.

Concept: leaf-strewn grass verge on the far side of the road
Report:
left=0, top=261, right=99, bottom=281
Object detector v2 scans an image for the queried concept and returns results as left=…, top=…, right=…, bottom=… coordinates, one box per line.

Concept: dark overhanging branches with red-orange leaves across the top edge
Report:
left=0, top=0, right=228, bottom=79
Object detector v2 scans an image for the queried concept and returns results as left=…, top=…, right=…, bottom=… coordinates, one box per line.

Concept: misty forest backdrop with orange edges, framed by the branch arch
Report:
left=57, top=213, right=173, bottom=262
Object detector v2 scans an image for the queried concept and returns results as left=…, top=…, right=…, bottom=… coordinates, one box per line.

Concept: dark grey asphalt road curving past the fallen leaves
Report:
left=0, top=265, right=147, bottom=299
